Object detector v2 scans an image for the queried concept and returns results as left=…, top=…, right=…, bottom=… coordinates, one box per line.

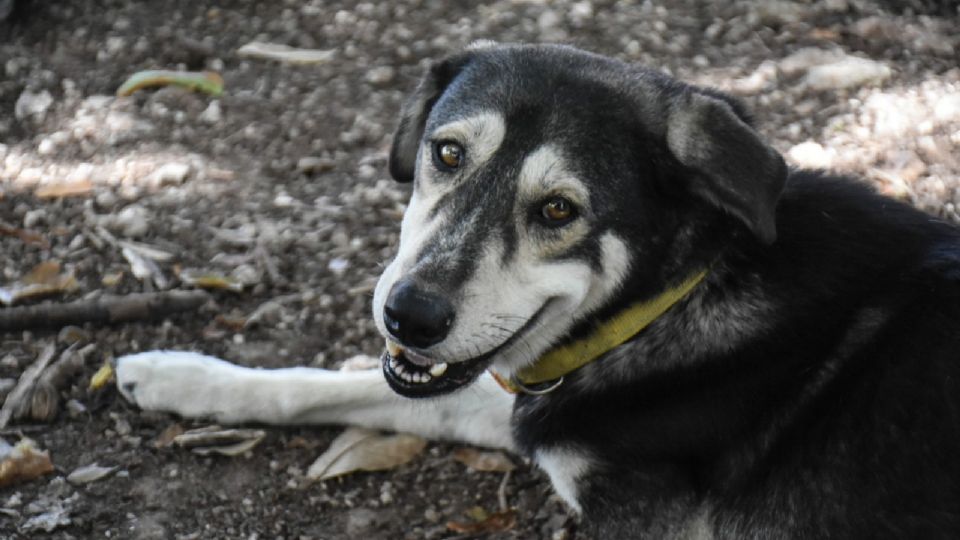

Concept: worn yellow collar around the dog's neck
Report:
left=490, top=270, right=707, bottom=394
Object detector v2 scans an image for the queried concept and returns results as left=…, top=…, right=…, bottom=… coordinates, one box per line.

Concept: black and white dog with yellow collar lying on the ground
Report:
left=117, top=43, right=960, bottom=539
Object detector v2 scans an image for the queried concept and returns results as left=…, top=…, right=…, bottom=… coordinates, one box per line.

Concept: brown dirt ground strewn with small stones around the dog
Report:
left=0, top=0, right=960, bottom=539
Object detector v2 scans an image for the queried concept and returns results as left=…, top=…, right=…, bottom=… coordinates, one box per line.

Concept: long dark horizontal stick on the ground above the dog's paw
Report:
left=0, top=290, right=210, bottom=332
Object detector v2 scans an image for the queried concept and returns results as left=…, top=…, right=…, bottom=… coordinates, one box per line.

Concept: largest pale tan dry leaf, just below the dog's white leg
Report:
left=307, top=427, right=427, bottom=480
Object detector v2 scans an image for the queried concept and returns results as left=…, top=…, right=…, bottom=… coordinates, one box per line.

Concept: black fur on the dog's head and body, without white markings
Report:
left=391, top=46, right=960, bottom=539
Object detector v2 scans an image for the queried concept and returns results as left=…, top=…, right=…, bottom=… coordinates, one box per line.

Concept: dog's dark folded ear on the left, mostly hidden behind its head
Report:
left=390, top=53, right=469, bottom=182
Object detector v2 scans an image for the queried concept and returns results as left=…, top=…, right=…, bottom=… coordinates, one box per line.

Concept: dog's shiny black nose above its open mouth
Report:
left=383, top=280, right=454, bottom=348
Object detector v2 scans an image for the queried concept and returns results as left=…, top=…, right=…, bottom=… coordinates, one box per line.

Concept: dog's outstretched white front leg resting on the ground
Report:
left=117, top=351, right=513, bottom=449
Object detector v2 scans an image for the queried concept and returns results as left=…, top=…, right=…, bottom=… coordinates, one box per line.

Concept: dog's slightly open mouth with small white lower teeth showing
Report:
left=380, top=297, right=557, bottom=398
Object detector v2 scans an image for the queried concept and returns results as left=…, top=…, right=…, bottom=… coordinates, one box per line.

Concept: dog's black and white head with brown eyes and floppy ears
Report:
left=373, top=44, right=786, bottom=397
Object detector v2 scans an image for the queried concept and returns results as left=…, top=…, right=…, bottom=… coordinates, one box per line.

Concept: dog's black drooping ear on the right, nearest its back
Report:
left=667, top=89, right=787, bottom=244
